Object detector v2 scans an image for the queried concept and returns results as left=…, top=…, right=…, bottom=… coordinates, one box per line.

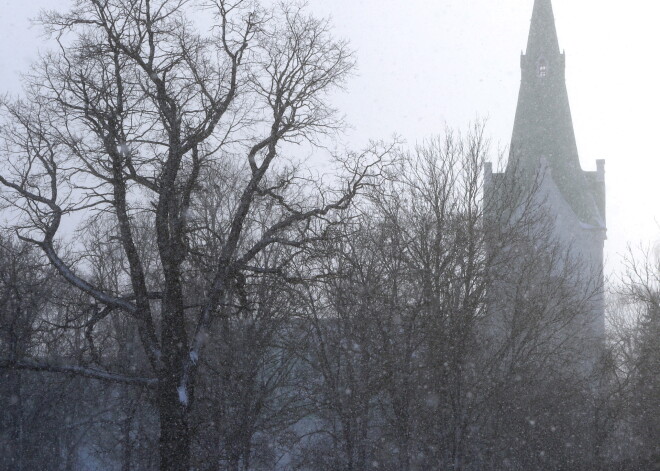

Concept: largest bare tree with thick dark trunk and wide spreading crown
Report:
left=0, top=0, right=386, bottom=470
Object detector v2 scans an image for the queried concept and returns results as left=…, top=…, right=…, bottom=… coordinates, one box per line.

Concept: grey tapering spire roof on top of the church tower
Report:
left=507, top=0, right=603, bottom=225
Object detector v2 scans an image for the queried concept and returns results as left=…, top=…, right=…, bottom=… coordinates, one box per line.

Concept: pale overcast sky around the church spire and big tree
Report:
left=0, top=0, right=660, bottom=276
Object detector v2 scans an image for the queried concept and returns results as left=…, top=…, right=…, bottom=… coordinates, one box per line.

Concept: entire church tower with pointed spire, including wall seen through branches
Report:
left=483, top=0, right=607, bottom=366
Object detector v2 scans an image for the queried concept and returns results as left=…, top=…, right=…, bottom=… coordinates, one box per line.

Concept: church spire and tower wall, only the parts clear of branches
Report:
left=484, top=0, right=606, bottom=346
